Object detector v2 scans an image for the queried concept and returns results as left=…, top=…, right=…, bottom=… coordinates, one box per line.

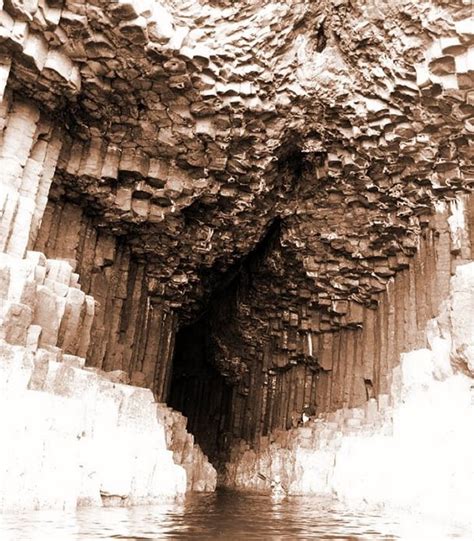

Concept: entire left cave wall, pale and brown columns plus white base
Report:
left=0, top=93, right=216, bottom=511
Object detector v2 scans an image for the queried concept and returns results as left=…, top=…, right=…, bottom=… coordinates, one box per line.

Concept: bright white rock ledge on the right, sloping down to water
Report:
left=224, top=256, right=474, bottom=528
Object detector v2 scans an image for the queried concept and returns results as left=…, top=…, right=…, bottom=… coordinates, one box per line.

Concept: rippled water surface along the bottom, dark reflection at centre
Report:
left=0, top=491, right=471, bottom=541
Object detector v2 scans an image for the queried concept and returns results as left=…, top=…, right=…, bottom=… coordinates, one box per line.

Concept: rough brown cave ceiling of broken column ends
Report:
left=1, top=0, right=474, bottom=342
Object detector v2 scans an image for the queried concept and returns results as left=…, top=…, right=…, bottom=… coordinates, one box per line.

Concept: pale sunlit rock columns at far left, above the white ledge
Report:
left=0, top=93, right=94, bottom=357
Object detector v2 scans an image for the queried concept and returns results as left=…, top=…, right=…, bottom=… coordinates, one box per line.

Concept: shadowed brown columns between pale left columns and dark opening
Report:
left=34, top=199, right=176, bottom=396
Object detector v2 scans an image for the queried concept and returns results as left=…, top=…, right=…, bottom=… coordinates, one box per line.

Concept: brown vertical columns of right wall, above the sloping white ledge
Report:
left=171, top=197, right=474, bottom=464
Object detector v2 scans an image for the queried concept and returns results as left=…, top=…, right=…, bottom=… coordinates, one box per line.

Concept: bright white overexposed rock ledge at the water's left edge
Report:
left=0, top=342, right=186, bottom=511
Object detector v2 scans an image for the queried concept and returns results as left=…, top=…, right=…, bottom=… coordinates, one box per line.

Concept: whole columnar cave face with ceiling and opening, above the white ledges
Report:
left=0, top=0, right=474, bottom=516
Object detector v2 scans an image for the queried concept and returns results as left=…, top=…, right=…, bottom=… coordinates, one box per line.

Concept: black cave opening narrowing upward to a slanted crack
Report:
left=167, top=216, right=282, bottom=469
